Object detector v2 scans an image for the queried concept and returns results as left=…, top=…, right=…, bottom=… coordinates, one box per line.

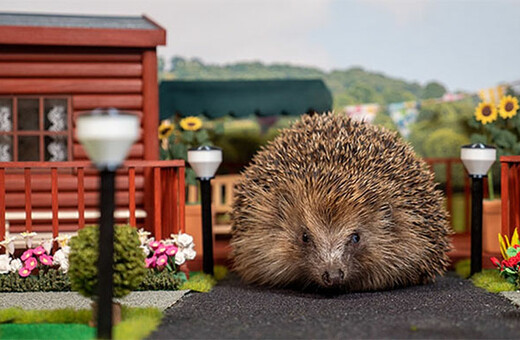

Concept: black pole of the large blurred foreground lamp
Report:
left=97, top=169, right=115, bottom=339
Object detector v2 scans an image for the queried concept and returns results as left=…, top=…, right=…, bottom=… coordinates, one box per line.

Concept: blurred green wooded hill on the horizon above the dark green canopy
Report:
left=159, top=57, right=446, bottom=110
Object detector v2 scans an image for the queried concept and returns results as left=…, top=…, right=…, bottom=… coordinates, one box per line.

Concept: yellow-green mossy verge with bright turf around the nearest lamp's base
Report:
left=0, top=306, right=162, bottom=339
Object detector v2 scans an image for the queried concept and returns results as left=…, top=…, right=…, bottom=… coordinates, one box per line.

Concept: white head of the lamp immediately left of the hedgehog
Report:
left=188, top=146, right=222, bottom=180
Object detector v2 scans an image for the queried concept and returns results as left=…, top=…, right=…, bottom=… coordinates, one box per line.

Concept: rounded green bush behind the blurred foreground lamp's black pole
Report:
left=69, top=225, right=146, bottom=297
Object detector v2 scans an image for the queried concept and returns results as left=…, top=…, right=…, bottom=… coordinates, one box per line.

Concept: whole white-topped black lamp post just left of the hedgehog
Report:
left=188, top=146, right=222, bottom=275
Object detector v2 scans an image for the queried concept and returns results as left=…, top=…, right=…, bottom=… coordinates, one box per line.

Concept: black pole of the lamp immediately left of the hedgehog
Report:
left=199, top=178, right=213, bottom=275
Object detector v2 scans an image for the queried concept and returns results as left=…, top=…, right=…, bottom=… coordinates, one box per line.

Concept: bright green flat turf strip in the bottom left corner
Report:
left=0, top=323, right=96, bottom=340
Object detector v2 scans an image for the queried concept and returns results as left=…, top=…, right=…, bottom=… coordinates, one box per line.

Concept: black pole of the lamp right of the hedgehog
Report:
left=471, top=175, right=484, bottom=275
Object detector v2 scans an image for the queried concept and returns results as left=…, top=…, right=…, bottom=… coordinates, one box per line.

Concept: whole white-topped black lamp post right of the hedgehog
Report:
left=460, top=143, right=497, bottom=275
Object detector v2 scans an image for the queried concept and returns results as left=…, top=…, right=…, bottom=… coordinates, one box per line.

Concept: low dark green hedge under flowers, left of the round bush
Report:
left=0, top=268, right=70, bottom=292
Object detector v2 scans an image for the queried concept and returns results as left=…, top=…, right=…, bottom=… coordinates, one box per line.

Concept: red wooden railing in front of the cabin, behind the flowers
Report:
left=0, top=160, right=185, bottom=239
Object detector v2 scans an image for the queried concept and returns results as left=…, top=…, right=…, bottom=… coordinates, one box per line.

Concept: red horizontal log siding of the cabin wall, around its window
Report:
left=0, top=45, right=158, bottom=231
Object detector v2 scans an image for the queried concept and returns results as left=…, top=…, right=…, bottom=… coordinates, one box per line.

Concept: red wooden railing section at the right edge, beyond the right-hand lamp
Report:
left=500, top=156, right=520, bottom=237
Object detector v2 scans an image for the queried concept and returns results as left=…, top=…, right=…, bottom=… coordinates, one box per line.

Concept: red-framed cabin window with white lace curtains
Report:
left=0, top=96, right=71, bottom=162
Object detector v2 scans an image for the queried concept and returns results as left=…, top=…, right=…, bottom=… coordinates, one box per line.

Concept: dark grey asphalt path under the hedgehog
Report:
left=150, top=275, right=520, bottom=339
